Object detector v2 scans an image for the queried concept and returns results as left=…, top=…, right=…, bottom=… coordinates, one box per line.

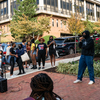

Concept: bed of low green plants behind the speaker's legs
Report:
left=56, top=61, right=100, bottom=77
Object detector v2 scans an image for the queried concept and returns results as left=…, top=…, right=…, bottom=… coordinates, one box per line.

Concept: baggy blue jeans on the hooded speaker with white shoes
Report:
left=77, top=55, right=95, bottom=82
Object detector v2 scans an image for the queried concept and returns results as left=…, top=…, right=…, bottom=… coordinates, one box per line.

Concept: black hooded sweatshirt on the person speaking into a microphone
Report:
left=79, top=31, right=94, bottom=56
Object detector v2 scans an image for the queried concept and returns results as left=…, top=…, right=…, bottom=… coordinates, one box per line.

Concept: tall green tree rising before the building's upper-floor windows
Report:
left=12, top=0, right=37, bottom=21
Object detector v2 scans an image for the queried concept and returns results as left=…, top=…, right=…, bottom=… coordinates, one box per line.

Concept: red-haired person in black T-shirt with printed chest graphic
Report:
left=36, top=38, right=47, bottom=70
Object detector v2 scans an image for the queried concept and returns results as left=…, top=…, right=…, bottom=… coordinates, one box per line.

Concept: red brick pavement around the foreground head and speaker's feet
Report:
left=0, top=71, right=100, bottom=100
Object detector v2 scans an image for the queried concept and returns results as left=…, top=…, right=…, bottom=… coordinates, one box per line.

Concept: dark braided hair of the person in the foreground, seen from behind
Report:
left=30, top=73, right=61, bottom=100
